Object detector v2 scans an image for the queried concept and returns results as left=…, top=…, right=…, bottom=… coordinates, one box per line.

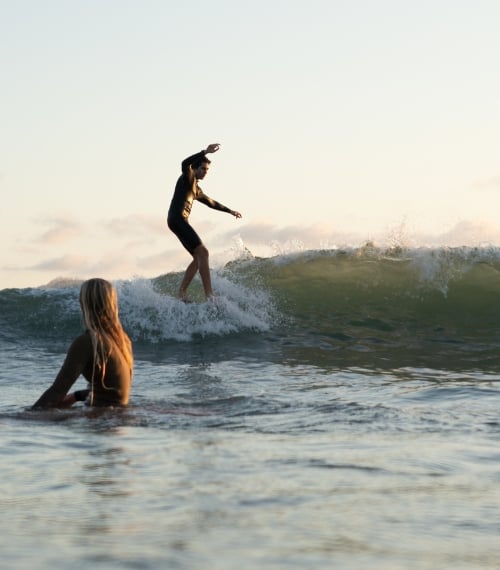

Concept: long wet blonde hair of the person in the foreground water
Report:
left=80, top=278, right=134, bottom=398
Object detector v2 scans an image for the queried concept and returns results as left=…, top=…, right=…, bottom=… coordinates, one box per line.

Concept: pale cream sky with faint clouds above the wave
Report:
left=0, top=0, right=500, bottom=289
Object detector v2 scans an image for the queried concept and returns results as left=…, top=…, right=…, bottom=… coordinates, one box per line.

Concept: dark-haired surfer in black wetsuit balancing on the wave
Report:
left=167, top=143, right=241, bottom=301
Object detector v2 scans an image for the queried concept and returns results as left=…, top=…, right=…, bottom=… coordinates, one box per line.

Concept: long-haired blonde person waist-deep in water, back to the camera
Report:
left=33, top=279, right=134, bottom=408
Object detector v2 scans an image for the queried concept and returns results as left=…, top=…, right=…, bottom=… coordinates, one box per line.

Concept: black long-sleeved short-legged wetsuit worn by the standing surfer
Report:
left=167, top=151, right=231, bottom=255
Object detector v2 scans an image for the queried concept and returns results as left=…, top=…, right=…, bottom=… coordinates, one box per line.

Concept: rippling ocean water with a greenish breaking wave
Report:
left=0, top=244, right=500, bottom=570
